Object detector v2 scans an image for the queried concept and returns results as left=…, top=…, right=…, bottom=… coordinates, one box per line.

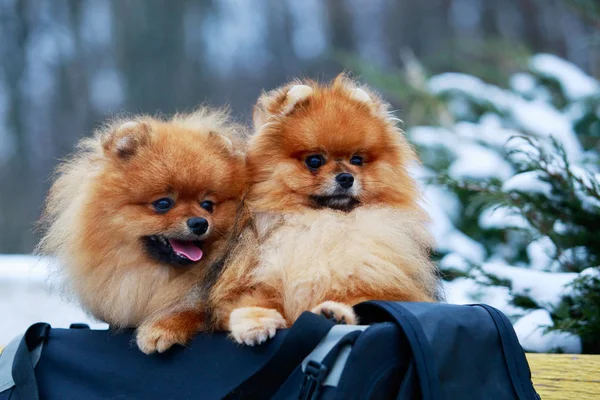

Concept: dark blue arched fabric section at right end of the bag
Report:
left=356, top=301, right=539, bottom=400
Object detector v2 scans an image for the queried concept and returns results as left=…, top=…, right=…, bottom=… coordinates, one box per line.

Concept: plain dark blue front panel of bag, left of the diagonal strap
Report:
left=36, top=329, right=288, bottom=400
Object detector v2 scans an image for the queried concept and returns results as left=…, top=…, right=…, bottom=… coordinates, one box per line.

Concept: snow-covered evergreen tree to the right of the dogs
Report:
left=358, top=54, right=600, bottom=352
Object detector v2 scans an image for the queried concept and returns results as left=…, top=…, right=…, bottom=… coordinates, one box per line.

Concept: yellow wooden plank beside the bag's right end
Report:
left=527, top=354, right=600, bottom=400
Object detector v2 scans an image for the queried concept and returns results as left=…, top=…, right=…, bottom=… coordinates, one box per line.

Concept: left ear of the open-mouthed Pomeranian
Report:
left=102, top=120, right=152, bottom=160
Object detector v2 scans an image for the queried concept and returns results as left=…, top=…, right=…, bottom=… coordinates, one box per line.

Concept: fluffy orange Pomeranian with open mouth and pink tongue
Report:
left=39, top=109, right=246, bottom=353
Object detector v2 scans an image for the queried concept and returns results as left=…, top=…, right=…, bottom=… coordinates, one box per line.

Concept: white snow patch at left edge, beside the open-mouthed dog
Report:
left=0, top=255, right=107, bottom=346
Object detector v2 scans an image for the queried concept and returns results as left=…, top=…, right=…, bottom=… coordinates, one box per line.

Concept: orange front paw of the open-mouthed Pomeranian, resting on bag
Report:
left=136, top=312, right=202, bottom=354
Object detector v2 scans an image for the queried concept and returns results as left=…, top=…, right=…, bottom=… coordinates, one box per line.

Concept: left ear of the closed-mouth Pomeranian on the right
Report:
left=252, top=82, right=314, bottom=129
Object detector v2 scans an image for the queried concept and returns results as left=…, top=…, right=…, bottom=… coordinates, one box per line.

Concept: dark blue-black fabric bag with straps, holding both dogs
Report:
left=0, top=301, right=539, bottom=400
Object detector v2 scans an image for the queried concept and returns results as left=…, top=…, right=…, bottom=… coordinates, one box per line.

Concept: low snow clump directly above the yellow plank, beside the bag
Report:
left=514, top=309, right=581, bottom=353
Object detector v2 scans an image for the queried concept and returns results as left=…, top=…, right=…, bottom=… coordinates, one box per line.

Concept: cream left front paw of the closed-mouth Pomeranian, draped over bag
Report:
left=229, top=307, right=287, bottom=346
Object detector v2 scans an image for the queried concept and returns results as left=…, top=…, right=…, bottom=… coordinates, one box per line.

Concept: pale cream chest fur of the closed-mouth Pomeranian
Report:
left=254, top=207, right=429, bottom=319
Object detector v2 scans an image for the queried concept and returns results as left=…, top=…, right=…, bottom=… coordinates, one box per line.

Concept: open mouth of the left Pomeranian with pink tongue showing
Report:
left=143, top=235, right=203, bottom=266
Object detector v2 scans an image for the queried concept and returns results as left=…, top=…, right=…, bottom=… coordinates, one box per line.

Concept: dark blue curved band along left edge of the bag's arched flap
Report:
left=356, top=301, right=442, bottom=400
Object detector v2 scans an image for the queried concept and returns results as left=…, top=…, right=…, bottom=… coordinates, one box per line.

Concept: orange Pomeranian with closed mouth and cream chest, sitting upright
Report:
left=211, top=75, right=438, bottom=345
